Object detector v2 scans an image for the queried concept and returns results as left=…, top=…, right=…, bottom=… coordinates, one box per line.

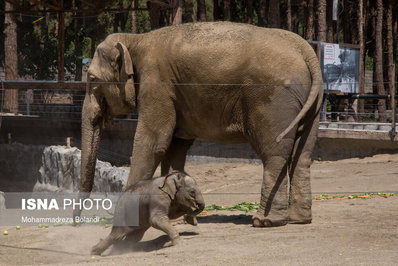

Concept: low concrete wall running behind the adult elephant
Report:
left=0, top=117, right=398, bottom=165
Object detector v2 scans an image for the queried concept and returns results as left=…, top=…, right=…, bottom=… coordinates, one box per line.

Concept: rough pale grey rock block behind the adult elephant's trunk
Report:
left=33, top=146, right=129, bottom=192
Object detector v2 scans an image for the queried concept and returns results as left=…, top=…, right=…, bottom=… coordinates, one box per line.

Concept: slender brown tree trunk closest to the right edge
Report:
left=385, top=0, right=395, bottom=120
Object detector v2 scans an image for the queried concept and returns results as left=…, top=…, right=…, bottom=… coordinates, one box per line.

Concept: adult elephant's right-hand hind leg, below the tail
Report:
left=288, top=116, right=319, bottom=224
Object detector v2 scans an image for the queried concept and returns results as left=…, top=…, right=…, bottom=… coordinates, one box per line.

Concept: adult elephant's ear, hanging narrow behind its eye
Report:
left=116, top=42, right=136, bottom=108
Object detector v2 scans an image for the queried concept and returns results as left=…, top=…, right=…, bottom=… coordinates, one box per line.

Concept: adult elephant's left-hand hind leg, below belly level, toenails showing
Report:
left=252, top=156, right=288, bottom=227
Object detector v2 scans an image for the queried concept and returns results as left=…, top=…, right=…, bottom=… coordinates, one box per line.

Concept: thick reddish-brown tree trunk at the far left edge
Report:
left=0, top=2, right=18, bottom=113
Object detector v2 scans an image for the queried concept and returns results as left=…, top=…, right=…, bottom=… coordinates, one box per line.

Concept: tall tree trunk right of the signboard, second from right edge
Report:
left=373, top=0, right=387, bottom=122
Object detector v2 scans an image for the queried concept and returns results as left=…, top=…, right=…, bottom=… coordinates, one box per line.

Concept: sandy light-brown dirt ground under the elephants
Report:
left=0, top=155, right=398, bottom=265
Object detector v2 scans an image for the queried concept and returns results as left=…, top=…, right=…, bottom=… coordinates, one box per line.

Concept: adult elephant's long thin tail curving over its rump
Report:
left=276, top=43, right=323, bottom=143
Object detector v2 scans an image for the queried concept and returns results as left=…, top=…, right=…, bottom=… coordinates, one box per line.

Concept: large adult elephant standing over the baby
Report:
left=75, top=22, right=323, bottom=226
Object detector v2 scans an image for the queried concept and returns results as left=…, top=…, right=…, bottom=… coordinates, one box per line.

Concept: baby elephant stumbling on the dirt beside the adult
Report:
left=91, top=172, right=205, bottom=255
